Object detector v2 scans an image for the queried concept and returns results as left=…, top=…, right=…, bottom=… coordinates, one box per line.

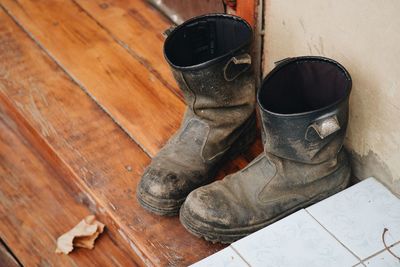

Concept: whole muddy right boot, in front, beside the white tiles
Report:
left=180, top=57, right=351, bottom=243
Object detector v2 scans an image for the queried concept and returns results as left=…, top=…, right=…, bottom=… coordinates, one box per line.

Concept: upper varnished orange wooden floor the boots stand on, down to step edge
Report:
left=0, top=0, right=261, bottom=266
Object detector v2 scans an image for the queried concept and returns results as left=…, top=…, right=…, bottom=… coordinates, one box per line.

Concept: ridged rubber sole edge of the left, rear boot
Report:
left=136, top=112, right=257, bottom=216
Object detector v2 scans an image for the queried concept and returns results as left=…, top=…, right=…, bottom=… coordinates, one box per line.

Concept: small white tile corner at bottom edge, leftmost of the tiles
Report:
left=191, top=247, right=248, bottom=267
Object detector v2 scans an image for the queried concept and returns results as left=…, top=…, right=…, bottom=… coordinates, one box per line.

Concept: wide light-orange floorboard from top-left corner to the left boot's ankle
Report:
left=1, top=0, right=184, bottom=155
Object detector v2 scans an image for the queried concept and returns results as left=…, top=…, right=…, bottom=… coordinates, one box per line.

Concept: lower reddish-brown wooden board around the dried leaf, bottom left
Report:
left=0, top=117, right=137, bottom=266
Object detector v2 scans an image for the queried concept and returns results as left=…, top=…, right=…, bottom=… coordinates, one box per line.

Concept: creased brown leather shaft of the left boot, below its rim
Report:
left=173, top=61, right=255, bottom=160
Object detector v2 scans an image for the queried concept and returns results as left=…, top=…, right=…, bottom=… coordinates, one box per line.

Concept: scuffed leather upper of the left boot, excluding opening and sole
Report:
left=137, top=58, right=256, bottom=216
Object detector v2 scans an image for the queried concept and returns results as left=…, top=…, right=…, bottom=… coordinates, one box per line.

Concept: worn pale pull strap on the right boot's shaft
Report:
left=305, top=115, right=340, bottom=141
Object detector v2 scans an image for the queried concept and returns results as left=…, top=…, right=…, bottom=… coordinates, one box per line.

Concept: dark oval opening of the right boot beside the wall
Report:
left=259, top=57, right=351, bottom=114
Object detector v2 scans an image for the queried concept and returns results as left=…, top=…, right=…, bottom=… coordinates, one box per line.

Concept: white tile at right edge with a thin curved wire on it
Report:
left=307, top=178, right=400, bottom=259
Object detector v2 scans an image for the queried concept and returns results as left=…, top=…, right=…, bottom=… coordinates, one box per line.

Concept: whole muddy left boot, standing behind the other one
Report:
left=136, top=14, right=256, bottom=215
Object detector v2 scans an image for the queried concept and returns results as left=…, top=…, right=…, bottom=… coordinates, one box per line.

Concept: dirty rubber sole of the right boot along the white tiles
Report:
left=179, top=165, right=350, bottom=244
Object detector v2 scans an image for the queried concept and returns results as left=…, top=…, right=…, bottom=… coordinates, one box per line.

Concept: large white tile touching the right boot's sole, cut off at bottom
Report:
left=232, top=210, right=359, bottom=267
